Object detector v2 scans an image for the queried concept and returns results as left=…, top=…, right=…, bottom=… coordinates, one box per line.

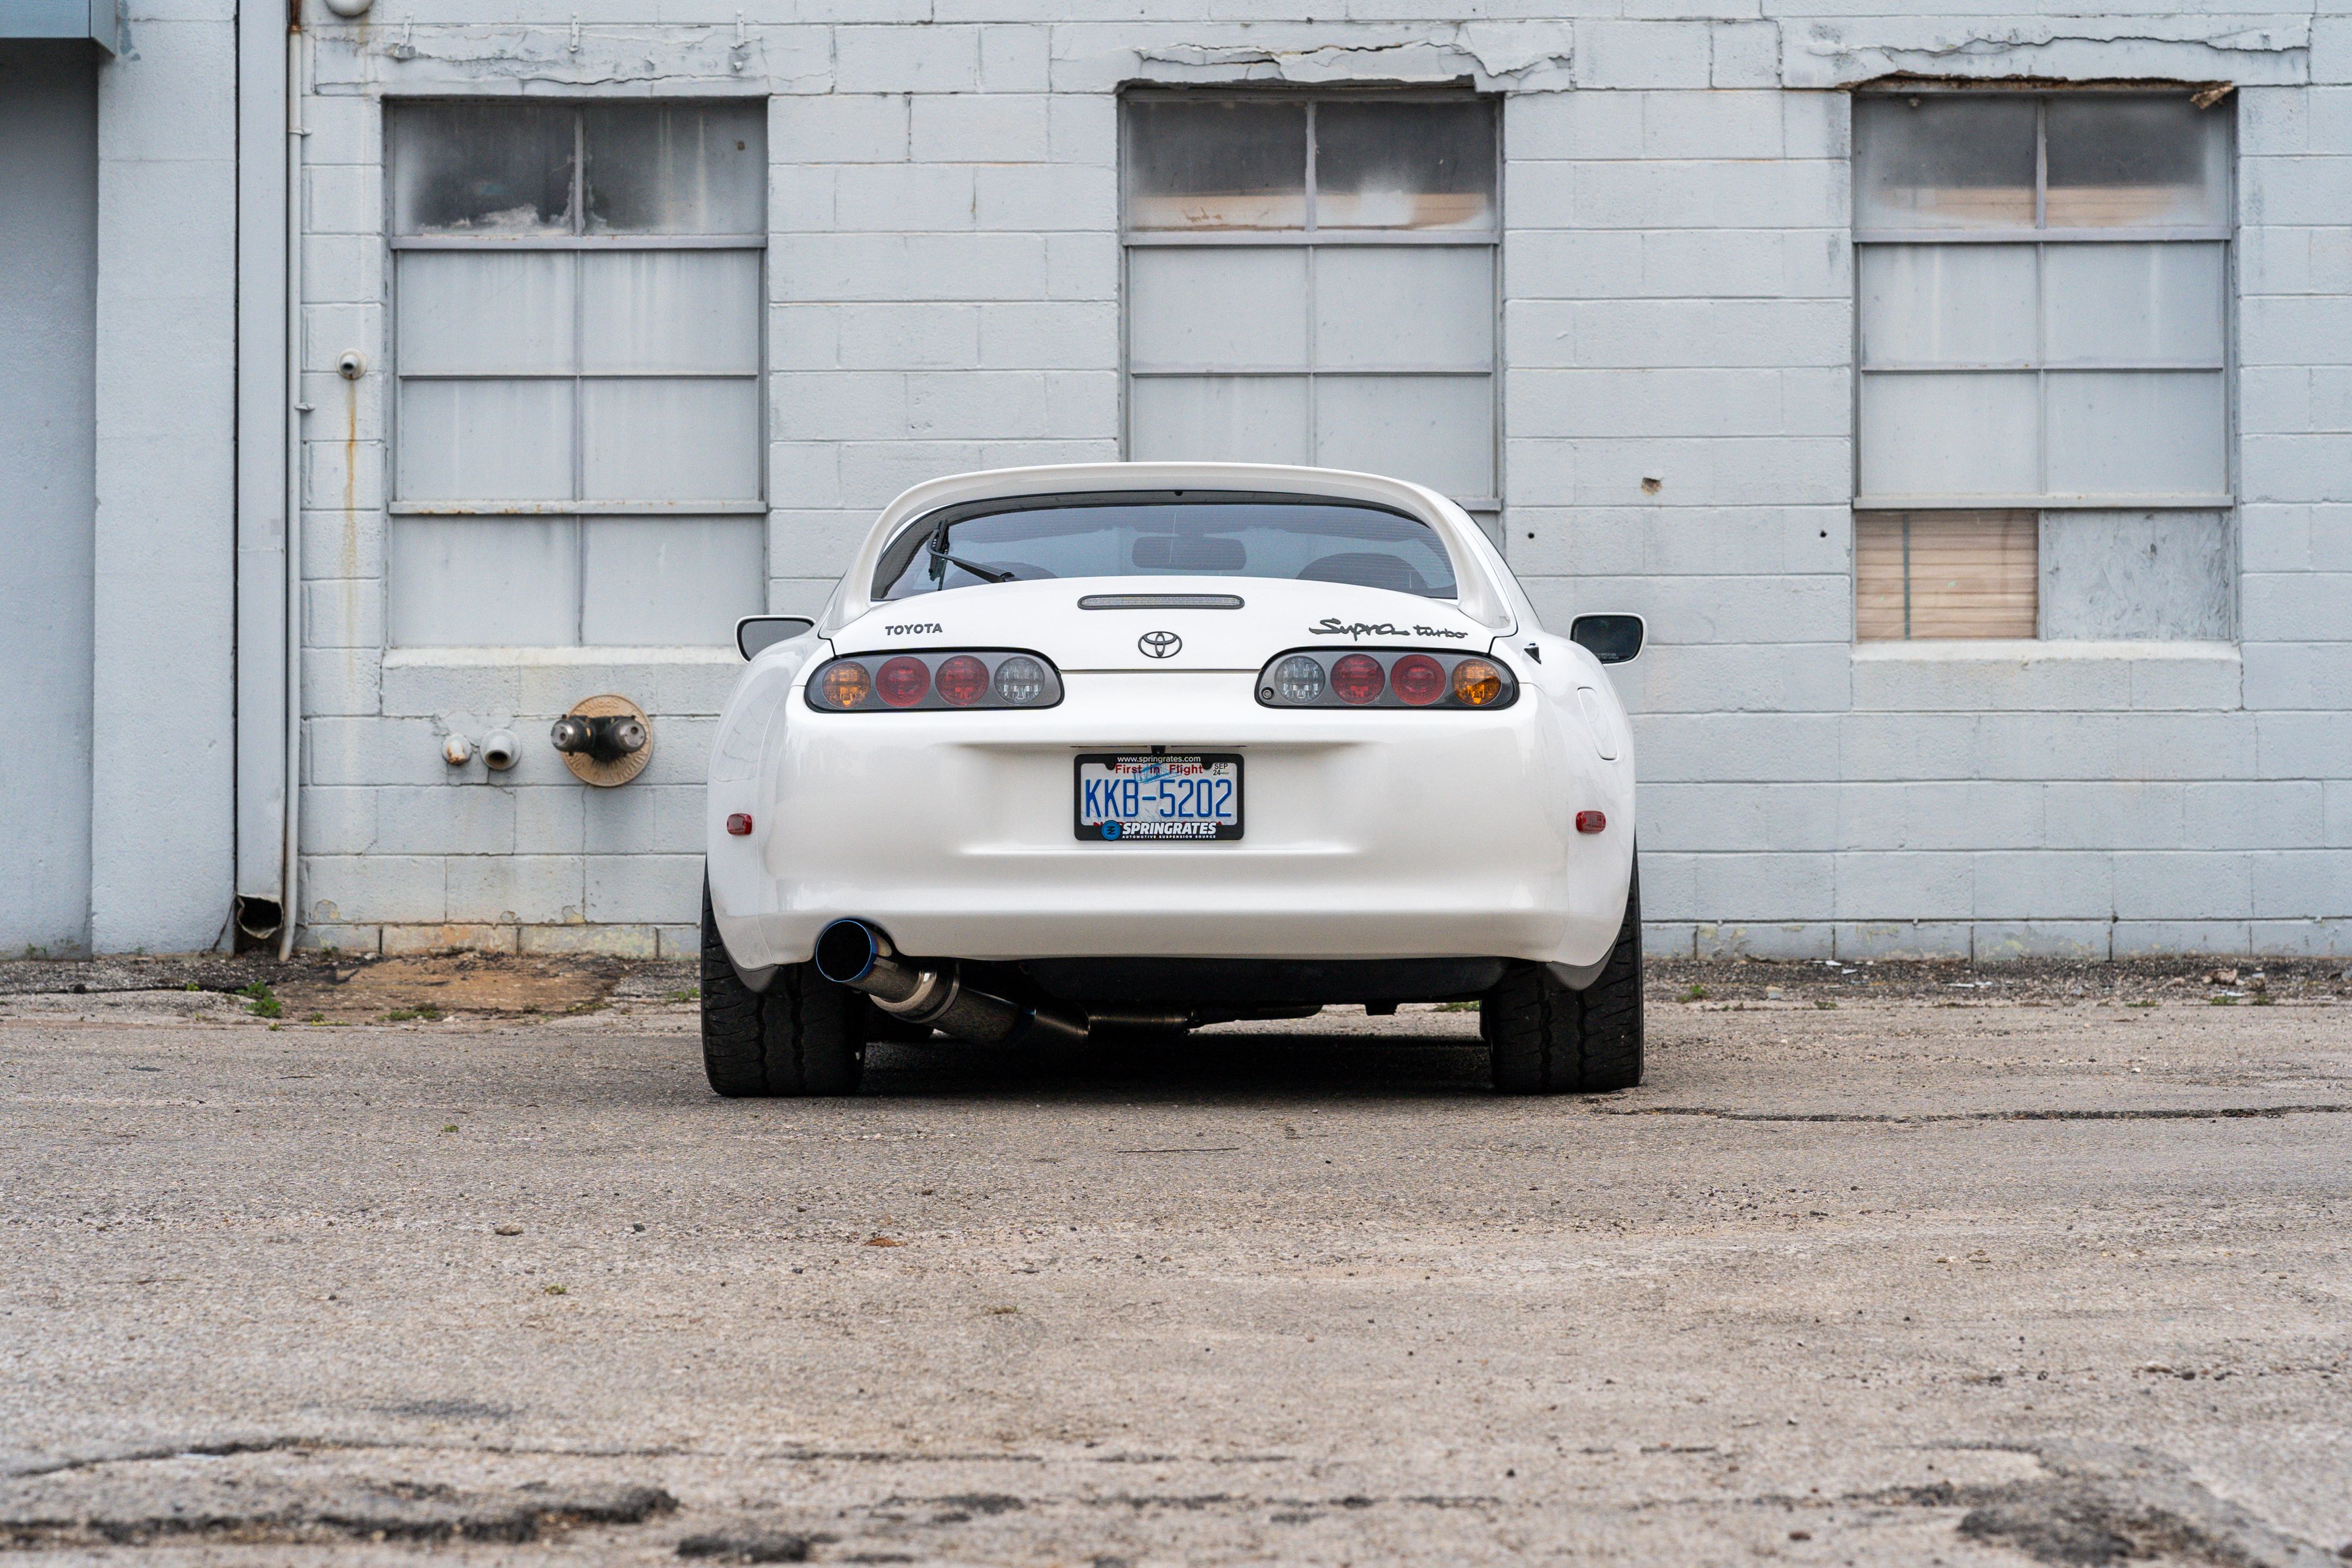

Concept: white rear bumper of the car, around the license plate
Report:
left=708, top=673, right=1632, bottom=968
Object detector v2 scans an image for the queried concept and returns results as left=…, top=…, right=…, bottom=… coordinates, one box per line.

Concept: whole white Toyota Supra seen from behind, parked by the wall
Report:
left=703, top=463, right=1642, bottom=1095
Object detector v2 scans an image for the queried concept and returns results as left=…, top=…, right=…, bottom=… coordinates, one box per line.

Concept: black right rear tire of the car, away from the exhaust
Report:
left=1479, top=855, right=1642, bottom=1095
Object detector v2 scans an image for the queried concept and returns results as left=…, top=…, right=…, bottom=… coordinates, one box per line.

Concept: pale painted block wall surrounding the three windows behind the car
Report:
left=289, top=0, right=2352, bottom=959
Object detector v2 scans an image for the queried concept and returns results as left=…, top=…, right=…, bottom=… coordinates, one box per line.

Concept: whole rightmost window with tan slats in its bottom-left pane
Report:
left=1853, top=92, right=2230, bottom=640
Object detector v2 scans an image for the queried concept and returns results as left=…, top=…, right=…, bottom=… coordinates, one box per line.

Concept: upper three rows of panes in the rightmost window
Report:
left=1856, top=94, right=2230, bottom=506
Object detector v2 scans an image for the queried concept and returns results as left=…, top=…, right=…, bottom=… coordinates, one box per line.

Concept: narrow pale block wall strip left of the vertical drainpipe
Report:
left=89, top=0, right=238, bottom=952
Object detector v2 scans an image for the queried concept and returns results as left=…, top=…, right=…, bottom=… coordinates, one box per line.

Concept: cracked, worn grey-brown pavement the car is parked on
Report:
left=0, top=966, right=2352, bottom=1568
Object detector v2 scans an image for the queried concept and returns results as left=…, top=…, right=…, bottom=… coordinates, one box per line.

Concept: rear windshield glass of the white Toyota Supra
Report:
left=875, top=492, right=1454, bottom=600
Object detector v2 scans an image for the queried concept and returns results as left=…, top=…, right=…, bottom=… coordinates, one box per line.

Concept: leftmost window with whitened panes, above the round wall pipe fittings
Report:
left=386, top=101, right=767, bottom=647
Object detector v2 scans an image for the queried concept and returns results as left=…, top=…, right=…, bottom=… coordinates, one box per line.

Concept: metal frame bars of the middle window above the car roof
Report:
left=1117, top=87, right=1508, bottom=514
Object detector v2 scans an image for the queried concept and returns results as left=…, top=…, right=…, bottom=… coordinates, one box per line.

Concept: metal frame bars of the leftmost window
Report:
left=379, top=92, right=774, bottom=658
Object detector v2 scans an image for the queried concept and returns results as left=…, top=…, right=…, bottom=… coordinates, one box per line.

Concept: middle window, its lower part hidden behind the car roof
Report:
left=1124, top=94, right=1501, bottom=526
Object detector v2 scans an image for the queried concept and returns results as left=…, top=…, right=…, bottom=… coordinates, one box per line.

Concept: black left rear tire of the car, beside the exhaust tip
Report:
left=703, top=879, right=866, bottom=1100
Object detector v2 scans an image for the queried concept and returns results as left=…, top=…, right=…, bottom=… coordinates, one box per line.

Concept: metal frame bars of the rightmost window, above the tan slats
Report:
left=1846, top=82, right=2239, bottom=515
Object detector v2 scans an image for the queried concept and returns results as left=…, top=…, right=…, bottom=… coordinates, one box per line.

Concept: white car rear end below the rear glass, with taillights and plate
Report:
left=710, top=514, right=1632, bottom=964
